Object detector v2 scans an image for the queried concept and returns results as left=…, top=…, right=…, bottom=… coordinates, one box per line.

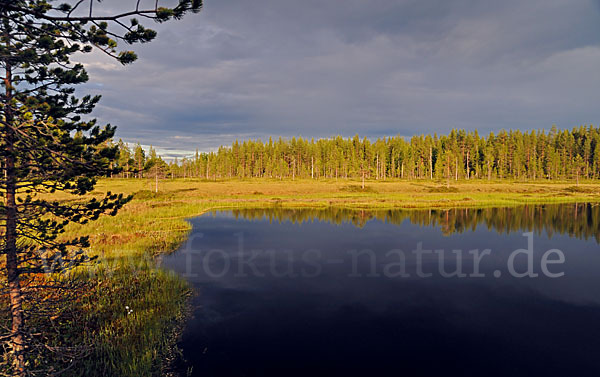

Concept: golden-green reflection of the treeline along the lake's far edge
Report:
left=214, top=203, right=600, bottom=243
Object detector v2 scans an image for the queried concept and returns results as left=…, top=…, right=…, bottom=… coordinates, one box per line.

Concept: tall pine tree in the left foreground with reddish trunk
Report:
left=0, top=0, right=201, bottom=376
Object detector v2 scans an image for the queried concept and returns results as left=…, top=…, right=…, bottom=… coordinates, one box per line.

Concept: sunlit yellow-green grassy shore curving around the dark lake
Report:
left=54, top=179, right=600, bottom=376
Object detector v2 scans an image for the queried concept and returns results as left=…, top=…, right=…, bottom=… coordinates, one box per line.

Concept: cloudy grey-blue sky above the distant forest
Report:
left=80, top=0, right=600, bottom=157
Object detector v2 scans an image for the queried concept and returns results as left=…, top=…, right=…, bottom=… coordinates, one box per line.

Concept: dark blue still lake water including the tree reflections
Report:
left=164, top=204, right=600, bottom=377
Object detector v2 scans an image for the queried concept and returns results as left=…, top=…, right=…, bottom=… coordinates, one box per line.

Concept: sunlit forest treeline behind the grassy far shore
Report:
left=117, top=126, right=600, bottom=180
